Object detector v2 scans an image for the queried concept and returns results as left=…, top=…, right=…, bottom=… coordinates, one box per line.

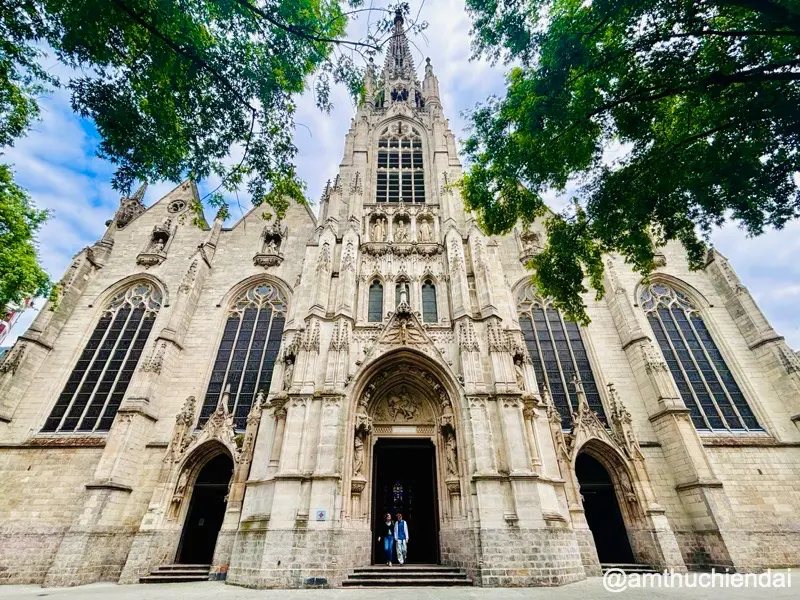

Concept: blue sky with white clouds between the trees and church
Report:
left=3, top=0, right=800, bottom=349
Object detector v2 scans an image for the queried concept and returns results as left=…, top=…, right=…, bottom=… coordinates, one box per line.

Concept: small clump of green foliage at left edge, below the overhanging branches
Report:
left=0, top=165, right=50, bottom=315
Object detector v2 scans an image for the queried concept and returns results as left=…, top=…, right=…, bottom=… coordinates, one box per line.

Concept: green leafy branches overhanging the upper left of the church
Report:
left=0, top=0, right=425, bottom=308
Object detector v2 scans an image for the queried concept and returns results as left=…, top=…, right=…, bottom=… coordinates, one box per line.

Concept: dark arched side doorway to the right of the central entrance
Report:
left=575, top=454, right=634, bottom=563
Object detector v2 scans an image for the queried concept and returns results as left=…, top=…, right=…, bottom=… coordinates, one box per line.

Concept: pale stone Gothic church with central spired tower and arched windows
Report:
left=0, top=10, right=800, bottom=587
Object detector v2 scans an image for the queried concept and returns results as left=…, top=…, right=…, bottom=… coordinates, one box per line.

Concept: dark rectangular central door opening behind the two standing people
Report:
left=372, top=439, right=439, bottom=564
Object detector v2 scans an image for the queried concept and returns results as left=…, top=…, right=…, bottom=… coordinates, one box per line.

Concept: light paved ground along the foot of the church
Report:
left=0, top=569, right=800, bottom=600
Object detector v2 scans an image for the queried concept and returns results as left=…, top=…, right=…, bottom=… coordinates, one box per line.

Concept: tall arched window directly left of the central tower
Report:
left=200, top=283, right=286, bottom=429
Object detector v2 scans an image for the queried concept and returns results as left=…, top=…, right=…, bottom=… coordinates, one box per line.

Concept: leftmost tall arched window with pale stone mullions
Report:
left=43, top=282, right=161, bottom=432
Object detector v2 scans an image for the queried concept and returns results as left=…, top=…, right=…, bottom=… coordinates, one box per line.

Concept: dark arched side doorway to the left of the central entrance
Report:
left=178, top=454, right=233, bottom=565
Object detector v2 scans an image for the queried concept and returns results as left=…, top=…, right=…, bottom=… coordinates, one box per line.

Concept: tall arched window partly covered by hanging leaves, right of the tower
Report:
left=517, top=286, right=605, bottom=428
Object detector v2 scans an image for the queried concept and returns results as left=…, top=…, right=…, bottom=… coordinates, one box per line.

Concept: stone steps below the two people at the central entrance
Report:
left=342, top=565, right=472, bottom=587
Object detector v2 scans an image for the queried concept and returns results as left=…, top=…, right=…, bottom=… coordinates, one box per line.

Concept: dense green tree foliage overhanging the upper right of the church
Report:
left=461, top=0, right=800, bottom=322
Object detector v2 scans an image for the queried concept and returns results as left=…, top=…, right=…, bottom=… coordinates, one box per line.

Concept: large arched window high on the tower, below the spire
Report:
left=375, top=122, right=425, bottom=203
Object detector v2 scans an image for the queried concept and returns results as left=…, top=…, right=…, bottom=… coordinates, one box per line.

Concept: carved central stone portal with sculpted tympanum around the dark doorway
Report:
left=347, top=351, right=465, bottom=562
